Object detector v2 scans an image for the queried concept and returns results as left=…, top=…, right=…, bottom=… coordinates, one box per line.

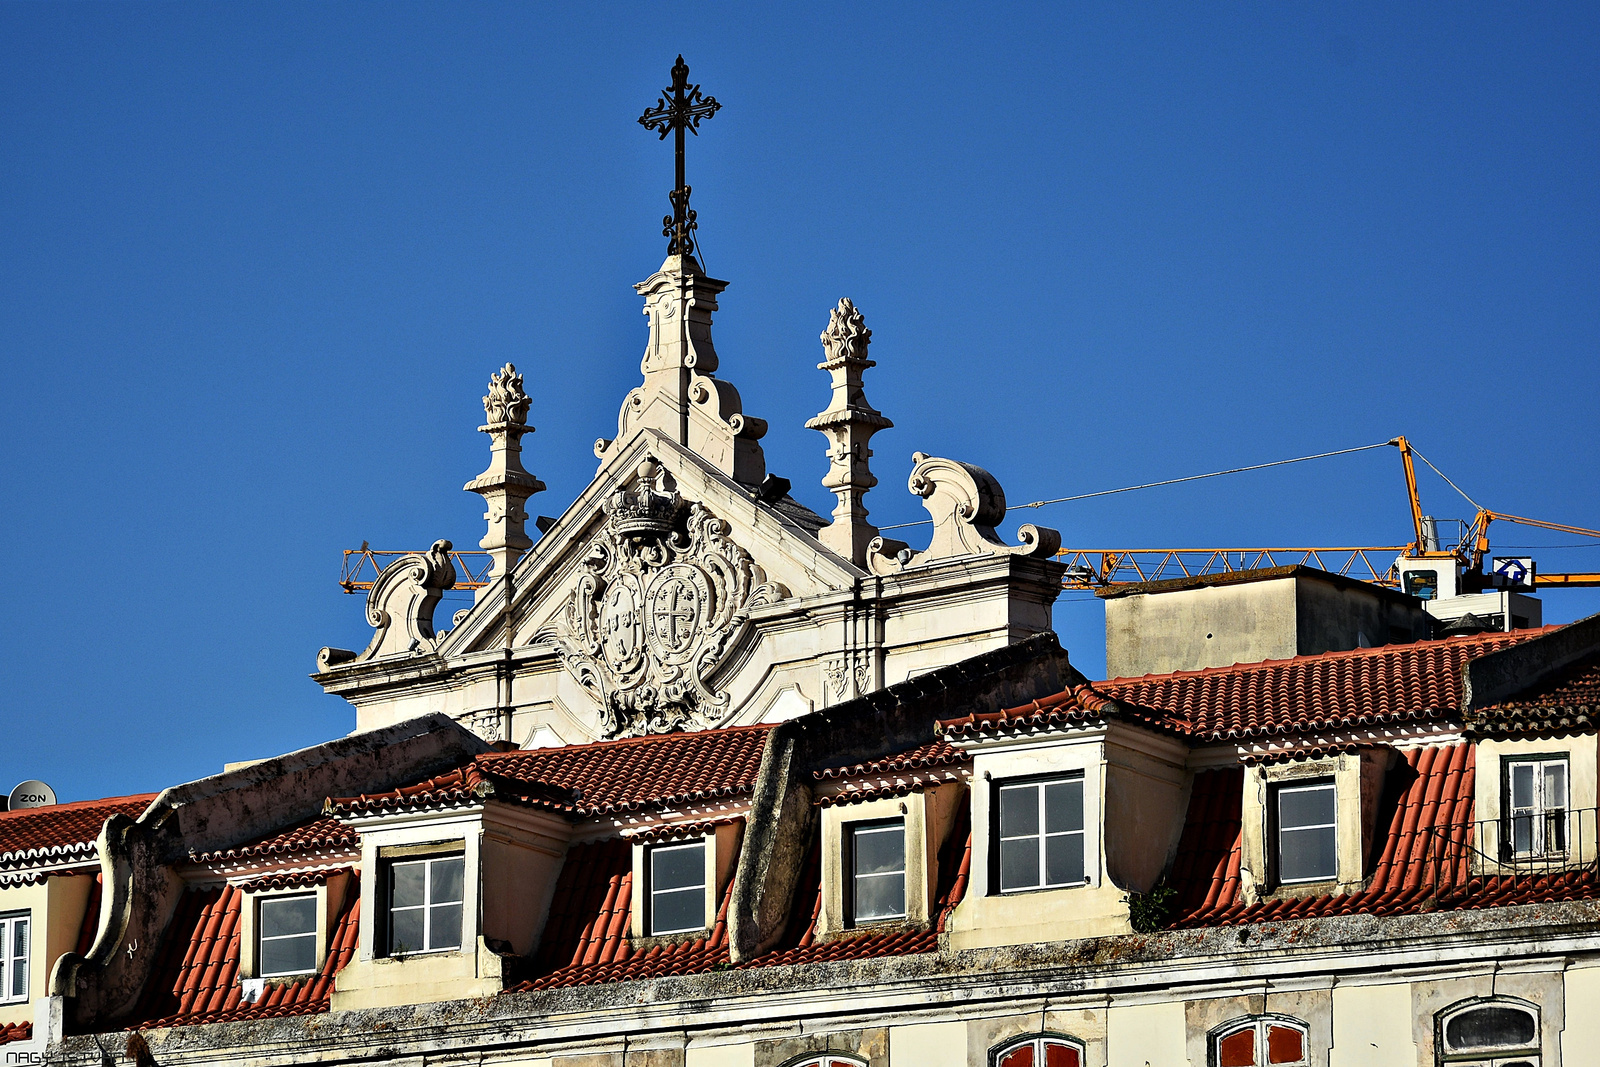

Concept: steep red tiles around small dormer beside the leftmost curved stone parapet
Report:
left=128, top=880, right=360, bottom=1030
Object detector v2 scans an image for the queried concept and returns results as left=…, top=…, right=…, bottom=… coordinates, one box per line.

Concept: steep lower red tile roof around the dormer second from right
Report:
left=1168, top=742, right=1600, bottom=926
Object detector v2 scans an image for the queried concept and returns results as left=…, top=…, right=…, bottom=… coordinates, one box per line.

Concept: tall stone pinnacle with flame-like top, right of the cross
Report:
left=806, top=298, right=894, bottom=566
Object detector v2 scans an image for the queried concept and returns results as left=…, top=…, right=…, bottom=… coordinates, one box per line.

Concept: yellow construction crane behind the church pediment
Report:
left=339, top=437, right=1600, bottom=593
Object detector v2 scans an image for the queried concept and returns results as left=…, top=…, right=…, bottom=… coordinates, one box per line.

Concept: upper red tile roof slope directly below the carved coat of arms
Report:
left=326, top=725, right=773, bottom=816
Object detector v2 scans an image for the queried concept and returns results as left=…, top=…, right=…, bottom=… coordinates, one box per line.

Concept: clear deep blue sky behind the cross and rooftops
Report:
left=0, top=3, right=1600, bottom=800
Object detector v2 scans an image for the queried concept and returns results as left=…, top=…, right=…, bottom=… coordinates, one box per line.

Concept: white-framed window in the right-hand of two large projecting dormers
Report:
left=998, top=773, right=1085, bottom=893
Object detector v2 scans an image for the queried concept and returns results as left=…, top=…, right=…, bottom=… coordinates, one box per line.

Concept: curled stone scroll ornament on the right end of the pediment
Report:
left=869, top=453, right=1061, bottom=574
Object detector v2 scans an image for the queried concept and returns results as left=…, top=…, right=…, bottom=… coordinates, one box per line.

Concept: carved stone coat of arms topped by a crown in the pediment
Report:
left=534, top=461, right=789, bottom=737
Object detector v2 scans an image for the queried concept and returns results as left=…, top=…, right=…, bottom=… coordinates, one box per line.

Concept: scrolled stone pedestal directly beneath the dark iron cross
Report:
left=595, top=256, right=766, bottom=486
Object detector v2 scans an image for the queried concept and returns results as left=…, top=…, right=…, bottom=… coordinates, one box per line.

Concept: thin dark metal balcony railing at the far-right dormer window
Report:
left=1406, top=808, right=1600, bottom=897
